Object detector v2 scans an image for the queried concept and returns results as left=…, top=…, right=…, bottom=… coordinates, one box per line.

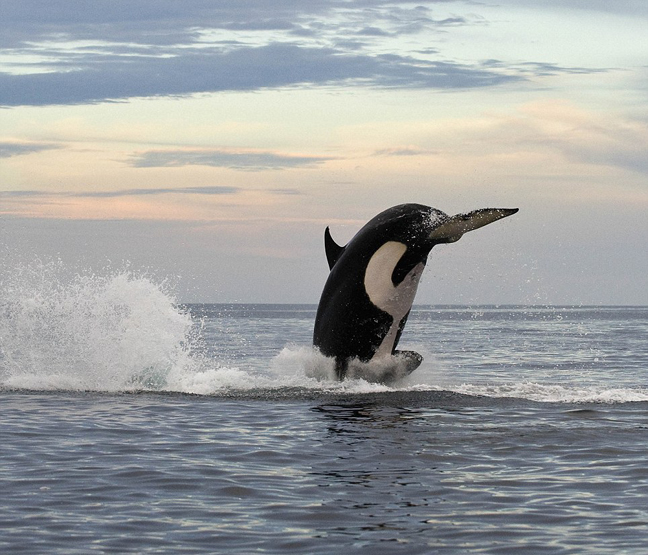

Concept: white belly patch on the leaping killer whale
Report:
left=364, top=241, right=425, bottom=359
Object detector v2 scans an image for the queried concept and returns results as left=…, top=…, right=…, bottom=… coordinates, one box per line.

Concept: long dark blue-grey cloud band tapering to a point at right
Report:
left=0, top=43, right=521, bottom=106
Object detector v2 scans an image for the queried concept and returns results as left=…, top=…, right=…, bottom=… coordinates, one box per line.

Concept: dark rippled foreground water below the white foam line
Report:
left=0, top=392, right=648, bottom=554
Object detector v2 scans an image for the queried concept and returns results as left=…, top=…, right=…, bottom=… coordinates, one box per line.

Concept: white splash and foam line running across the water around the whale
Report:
left=0, top=261, right=648, bottom=403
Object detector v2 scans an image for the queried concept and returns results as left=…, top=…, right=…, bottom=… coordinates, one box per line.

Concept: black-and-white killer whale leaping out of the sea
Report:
left=313, top=204, right=518, bottom=382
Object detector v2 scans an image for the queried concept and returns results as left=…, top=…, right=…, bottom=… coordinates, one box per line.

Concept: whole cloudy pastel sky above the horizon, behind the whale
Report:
left=0, top=0, right=648, bottom=305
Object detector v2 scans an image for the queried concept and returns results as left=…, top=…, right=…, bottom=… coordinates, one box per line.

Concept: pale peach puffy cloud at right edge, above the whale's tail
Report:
left=426, top=100, right=648, bottom=177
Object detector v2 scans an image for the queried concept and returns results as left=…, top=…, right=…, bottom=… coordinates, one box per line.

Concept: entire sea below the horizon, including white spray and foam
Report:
left=0, top=267, right=648, bottom=555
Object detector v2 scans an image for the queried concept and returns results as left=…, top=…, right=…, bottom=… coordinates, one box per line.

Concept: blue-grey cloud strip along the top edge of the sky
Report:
left=0, top=0, right=476, bottom=47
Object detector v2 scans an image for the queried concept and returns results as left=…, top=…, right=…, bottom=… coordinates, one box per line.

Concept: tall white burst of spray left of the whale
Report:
left=0, top=261, right=193, bottom=391
